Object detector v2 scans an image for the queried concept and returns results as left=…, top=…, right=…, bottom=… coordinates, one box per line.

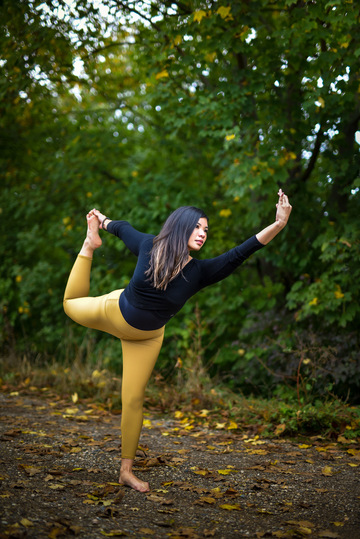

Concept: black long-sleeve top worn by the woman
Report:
left=107, top=221, right=264, bottom=330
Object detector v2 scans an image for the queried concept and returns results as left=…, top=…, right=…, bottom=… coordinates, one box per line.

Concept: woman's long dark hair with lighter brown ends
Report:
left=146, top=206, right=208, bottom=290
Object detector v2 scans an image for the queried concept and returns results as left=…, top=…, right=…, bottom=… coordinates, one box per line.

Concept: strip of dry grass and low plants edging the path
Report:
left=0, top=357, right=360, bottom=441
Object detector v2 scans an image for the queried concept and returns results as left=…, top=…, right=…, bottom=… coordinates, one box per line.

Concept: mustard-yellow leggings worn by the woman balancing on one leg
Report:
left=64, top=255, right=164, bottom=459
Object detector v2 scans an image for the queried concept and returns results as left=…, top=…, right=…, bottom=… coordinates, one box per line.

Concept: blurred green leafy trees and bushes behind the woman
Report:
left=0, top=0, right=360, bottom=434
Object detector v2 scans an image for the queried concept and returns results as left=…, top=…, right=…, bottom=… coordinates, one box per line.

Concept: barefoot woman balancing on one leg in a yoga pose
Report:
left=64, top=190, right=292, bottom=492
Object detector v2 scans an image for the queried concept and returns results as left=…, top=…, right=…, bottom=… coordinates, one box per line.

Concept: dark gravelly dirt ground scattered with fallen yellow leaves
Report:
left=0, top=392, right=360, bottom=539
